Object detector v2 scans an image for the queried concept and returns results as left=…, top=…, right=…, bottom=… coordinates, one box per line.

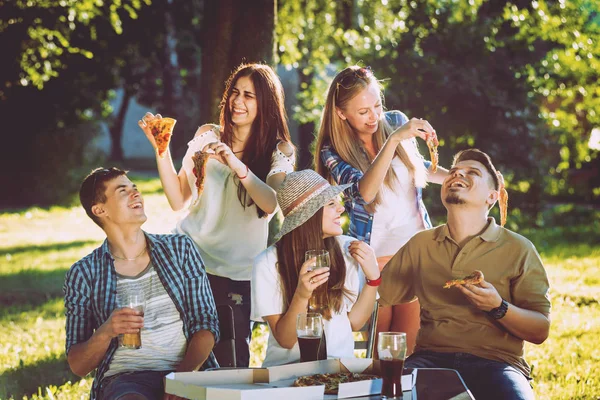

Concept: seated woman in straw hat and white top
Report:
left=252, top=170, right=381, bottom=367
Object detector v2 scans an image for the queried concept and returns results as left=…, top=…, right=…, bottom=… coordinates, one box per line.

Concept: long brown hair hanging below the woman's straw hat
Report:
left=275, top=207, right=353, bottom=320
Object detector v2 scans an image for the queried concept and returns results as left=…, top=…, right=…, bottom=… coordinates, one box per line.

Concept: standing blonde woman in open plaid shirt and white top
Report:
left=315, top=66, right=448, bottom=354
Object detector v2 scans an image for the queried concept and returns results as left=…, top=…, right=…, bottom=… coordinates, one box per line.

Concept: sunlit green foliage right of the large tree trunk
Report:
left=278, top=0, right=600, bottom=215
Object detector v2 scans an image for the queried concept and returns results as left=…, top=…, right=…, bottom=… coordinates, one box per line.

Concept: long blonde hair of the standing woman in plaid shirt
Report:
left=314, top=65, right=427, bottom=212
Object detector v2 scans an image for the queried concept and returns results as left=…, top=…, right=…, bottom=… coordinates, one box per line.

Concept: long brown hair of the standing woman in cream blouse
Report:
left=219, top=64, right=293, bottom=217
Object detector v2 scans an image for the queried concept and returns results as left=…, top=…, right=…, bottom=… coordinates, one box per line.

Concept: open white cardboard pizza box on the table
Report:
left=165, top=358, right=416, bottom=400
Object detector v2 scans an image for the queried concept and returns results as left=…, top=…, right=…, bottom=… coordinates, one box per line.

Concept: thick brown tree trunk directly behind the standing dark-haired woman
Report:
left=199, top=0, right=277, bottom=124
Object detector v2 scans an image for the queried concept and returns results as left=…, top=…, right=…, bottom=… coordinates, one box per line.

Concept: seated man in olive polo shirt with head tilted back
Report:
left=379, top=149, right=550, bottom=399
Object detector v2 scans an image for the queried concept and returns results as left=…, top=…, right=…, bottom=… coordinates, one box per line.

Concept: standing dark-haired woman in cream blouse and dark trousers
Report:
left=138, top=64, right=295, bottom=366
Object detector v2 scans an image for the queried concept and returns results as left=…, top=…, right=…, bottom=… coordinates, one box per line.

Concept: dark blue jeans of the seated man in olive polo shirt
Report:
left=405, top=351, right=535, bottom=400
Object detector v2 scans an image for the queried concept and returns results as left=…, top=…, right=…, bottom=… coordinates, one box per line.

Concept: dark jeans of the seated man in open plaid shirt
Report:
left=98, top=371, right=171, bottom=400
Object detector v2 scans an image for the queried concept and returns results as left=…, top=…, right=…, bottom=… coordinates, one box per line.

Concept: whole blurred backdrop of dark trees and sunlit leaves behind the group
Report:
left=0, top=0, right=600, bottom=228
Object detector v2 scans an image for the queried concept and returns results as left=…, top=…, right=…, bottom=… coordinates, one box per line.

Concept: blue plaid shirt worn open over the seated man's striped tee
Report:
left=63, top=233, right=219, bottom=399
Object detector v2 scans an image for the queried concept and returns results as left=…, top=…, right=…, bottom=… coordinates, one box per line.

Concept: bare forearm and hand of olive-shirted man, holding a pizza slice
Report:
left=457, top=281, right=550, bottom=344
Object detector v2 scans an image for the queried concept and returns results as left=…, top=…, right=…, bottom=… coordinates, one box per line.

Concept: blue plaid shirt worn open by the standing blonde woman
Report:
left=321, top=111, right=432, bottom=243
